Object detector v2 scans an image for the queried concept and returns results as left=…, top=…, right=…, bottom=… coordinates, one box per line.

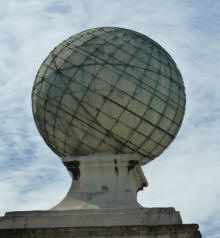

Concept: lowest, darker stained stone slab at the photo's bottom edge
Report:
left=0, top=224, right=201, bottom=238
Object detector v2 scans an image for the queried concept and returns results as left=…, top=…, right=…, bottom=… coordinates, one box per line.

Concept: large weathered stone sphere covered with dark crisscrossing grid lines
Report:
left=32, top=27, right=185, bottom=164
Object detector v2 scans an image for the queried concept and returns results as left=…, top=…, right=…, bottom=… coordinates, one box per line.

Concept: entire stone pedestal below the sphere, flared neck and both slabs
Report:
left=0, top=154, right=200, bottom=238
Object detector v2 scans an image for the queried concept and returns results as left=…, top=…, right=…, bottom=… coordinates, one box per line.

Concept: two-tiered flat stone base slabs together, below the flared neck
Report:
left=0, top=208, right=201, bottom=238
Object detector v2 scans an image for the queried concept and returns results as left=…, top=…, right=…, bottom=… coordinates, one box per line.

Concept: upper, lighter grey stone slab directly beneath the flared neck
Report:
left=0, top=208, right=182, bottom=229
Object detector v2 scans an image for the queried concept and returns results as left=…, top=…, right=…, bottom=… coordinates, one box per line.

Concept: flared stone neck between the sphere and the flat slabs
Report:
left=52, top=153, right=147, bottom=210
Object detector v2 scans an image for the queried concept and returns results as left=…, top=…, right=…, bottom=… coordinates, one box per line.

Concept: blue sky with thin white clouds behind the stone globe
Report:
left=0, top=0, right=220, bottom=238
